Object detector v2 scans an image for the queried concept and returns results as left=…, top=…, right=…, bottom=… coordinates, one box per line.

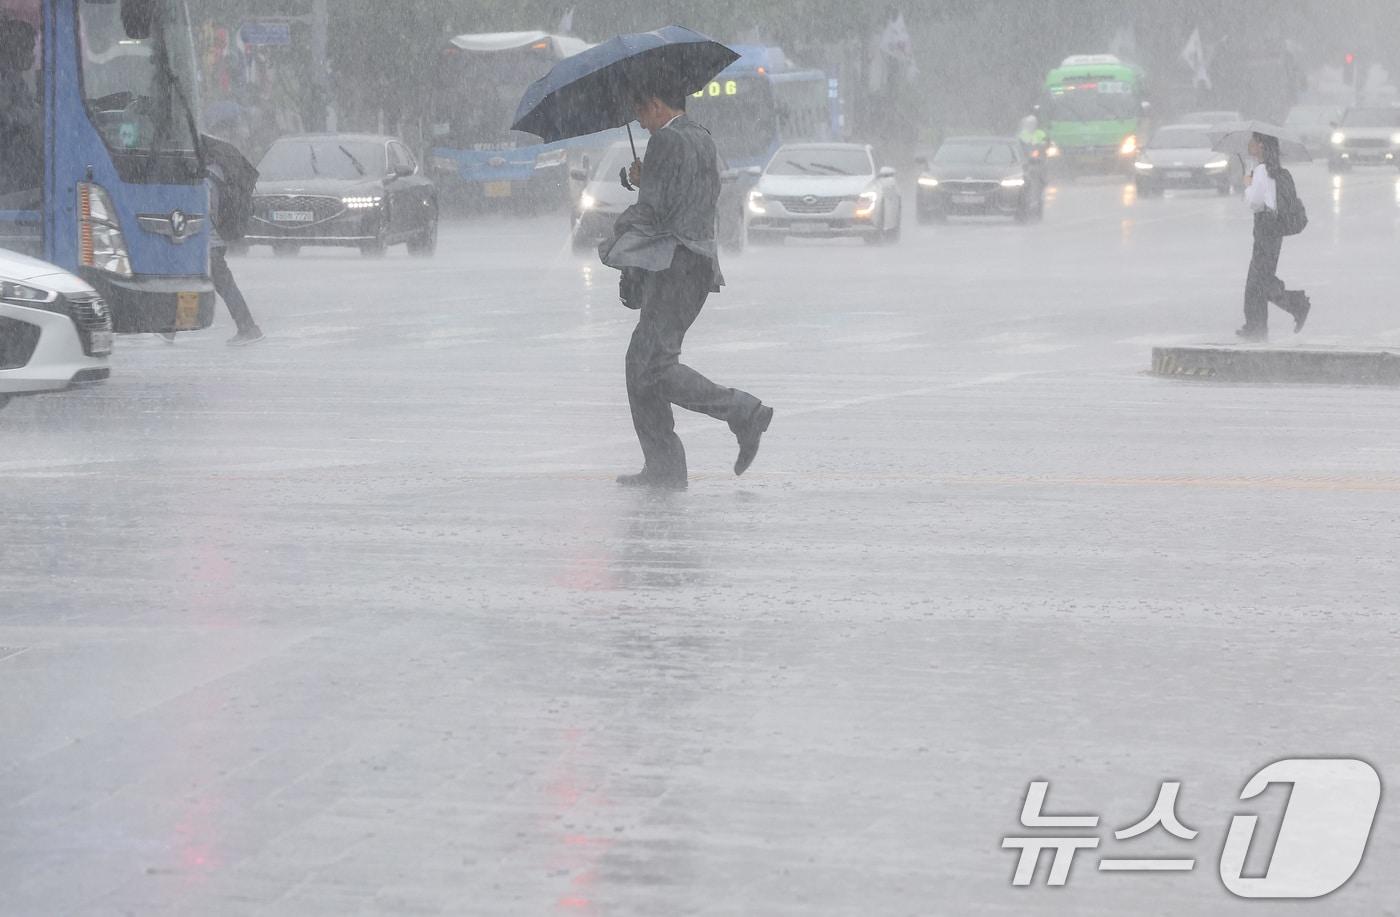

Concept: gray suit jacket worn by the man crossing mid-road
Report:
left=598, top=115, right=724, bottom=290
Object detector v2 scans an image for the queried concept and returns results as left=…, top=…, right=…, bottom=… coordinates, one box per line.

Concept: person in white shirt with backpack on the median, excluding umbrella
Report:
left=1235, top=133, right=1312, bottom=342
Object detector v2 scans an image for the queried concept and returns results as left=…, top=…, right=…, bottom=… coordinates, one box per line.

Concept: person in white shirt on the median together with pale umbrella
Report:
left=1215, top=122, right=1312, bottom=342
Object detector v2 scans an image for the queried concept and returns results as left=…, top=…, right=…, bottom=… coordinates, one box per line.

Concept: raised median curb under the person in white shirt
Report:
left=1152, top=344, right=1400, bottom=385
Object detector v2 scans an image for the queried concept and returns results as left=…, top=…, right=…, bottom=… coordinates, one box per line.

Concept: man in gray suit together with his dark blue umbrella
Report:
left=514, top=25, right=773, bottom=490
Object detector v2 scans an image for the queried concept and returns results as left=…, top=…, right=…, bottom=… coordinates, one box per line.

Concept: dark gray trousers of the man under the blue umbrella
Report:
left=627, top=248, right=759, bottom=477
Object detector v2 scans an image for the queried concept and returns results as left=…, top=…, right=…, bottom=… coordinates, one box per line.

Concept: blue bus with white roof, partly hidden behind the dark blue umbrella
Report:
left=428, top=32, right=626, bottom=210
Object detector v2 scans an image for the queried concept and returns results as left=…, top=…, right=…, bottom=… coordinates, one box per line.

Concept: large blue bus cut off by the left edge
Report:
left=0, top=0, right=214, bottom=332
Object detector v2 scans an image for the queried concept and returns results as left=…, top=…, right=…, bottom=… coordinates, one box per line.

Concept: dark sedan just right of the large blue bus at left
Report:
left=244, top=134, right=438, bottom=256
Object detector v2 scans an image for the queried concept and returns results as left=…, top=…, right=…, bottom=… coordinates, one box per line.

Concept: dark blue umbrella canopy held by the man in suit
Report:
left=511, top=25, right=739, bottom=143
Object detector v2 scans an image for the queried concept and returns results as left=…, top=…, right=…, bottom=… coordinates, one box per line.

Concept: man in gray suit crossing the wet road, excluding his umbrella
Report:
left=599, top=82, right=773, bottom=490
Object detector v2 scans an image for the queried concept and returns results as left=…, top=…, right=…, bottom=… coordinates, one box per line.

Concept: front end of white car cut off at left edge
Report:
left=0, top=249, right=112, bottom=405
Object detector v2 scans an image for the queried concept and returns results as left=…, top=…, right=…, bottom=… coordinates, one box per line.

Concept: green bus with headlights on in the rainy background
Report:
left=1037, top=55, right=1149, bottom=174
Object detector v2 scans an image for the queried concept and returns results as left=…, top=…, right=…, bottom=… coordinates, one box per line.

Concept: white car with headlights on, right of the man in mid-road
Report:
left=745, top=143, right=904, bottom=245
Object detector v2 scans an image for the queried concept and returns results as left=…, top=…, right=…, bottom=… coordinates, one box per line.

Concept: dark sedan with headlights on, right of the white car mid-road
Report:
left=916, top=137, right=1046, bottom=223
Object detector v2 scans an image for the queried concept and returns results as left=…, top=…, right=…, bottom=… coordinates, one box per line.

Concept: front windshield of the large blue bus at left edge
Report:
left=78, top=0, right=199, bottom=174
